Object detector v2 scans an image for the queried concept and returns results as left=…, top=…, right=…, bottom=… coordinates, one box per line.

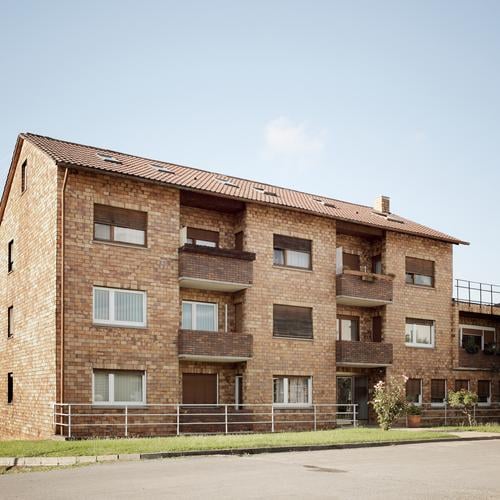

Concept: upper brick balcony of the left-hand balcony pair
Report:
left=179, top=245, right=255, bottom=292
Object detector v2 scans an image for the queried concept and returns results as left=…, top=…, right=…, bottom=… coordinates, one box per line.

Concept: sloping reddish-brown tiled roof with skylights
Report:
left=19, top=133, right=466, bottom=244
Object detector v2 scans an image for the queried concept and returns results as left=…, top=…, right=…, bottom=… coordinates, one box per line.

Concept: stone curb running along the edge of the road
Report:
left=0, top=434, right=500, bottom=468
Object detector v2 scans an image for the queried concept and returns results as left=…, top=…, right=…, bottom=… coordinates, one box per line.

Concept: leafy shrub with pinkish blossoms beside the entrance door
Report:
left=370, top=377, right=408, bottom=431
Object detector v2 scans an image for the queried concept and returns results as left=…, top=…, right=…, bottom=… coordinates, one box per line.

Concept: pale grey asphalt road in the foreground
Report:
left=0, top=440, right=500, bottom=500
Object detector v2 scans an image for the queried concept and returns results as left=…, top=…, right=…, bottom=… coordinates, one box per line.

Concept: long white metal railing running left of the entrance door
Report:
left=53, top=403, right=358, bottom=438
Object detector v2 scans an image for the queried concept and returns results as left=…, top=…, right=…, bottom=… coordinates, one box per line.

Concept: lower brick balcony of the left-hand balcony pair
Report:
left=178, top=330, right=253, bottom=363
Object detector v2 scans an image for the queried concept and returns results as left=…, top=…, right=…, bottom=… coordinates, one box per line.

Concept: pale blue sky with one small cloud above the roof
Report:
left=0, top=0, right=500, bottom=283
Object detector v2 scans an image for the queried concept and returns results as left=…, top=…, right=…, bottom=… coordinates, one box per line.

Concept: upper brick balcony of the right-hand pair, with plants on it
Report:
left=337, top=270, right=393, bottom=307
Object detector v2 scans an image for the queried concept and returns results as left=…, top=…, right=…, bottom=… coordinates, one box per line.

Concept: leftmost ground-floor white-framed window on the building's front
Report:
left=92, top=370, right=146, bottom=405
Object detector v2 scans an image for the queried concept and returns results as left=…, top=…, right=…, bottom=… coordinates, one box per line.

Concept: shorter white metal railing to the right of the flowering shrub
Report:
left=402, top=401, right=500, bottom=427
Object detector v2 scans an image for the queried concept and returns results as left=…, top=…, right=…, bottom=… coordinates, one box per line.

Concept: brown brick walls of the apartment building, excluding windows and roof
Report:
left=0, top=137, right=500, bottom=438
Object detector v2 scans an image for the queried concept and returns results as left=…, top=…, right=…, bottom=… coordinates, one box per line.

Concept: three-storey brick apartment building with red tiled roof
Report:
left=0, top=133, right=500, bottom=438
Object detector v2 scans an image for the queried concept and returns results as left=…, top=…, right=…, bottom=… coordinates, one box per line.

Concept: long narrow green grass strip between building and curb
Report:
left=0, top=428, right=452, bottom=457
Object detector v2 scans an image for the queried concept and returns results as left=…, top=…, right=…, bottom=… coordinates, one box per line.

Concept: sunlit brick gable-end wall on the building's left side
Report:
left=0, top=142, right=57, bottom=438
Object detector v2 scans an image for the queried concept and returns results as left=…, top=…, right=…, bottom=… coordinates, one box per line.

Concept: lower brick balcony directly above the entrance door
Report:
left=336, top=340, right=392, bottom=367
